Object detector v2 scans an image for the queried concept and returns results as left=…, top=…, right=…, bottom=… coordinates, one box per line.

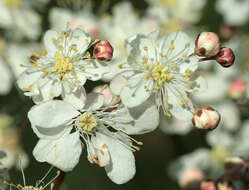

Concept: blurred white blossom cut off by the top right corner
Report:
left=216, top=0, right=249, bottom=26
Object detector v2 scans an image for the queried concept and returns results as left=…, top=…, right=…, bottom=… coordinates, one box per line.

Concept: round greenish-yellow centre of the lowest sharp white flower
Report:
left=77, top=112, right=98, bottom=132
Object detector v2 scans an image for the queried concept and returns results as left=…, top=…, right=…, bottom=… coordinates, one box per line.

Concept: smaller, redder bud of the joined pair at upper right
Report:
left=216, top=47, right=235, bottom=67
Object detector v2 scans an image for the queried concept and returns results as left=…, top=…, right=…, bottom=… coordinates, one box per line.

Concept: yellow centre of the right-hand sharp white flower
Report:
left=151, top=62, right=174, bottom=91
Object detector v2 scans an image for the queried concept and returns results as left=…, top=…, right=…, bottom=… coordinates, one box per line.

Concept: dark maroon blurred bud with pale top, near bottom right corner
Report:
left=225, top=157, right=247, bottom=180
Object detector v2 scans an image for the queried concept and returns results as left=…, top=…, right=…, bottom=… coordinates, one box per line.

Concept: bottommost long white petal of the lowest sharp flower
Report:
left=103, top=136, right=136, bottom=184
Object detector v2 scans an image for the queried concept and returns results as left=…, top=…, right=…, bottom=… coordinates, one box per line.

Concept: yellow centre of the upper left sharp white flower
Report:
left=52, top=53, right=73, bottom=79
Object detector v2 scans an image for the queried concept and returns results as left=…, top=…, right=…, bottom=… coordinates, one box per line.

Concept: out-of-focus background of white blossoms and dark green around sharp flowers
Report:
left=0, top=0, right=249, bottom=190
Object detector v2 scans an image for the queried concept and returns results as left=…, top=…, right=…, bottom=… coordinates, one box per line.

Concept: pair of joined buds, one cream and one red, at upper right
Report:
left=194, top=32, right=235, bottom=67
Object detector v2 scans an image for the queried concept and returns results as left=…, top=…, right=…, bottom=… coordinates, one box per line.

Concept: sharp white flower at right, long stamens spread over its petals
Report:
left=110, top=31, right=205, bottom=120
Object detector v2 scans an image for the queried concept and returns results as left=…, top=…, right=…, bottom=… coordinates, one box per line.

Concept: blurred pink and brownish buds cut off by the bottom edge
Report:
left=201, top=180, right=234, bottom=190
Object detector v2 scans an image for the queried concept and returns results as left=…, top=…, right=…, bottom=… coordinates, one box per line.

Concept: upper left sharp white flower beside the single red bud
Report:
left=17, top=28, right=107, bottom=106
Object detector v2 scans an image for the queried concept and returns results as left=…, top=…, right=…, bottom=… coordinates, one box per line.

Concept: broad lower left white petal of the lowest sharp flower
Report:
left=33, top=132, right=82, bottom=172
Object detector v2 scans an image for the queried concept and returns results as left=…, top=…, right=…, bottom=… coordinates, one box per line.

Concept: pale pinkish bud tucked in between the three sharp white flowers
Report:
left=93, top=85, right=120, bottom=106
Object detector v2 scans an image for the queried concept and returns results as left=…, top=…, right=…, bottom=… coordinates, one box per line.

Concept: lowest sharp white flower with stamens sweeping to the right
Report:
left=28, top=93, right=158, bottom=184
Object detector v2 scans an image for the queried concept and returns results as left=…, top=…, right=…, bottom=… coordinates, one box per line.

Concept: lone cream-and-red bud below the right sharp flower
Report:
left=192, top=107, right=220, bottom=130
